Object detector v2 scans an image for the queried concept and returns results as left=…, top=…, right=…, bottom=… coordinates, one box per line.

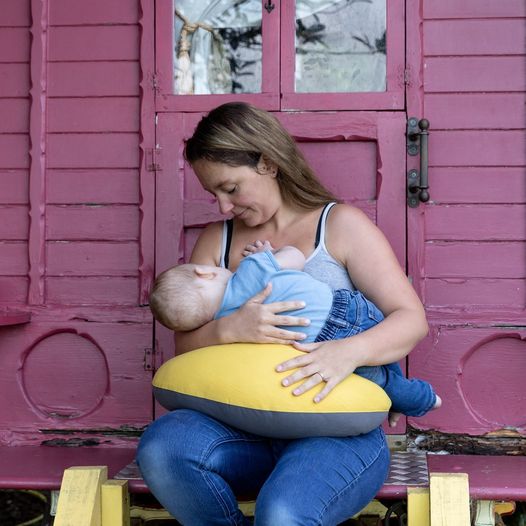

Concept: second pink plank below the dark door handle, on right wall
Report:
left=424, top=241, right=526, bottom=278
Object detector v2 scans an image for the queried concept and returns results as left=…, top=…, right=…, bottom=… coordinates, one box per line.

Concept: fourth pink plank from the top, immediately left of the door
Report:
left=47, top=97, right=140, bottom=132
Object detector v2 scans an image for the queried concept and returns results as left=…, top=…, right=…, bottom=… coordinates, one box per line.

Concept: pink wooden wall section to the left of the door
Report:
left=0, top=0, right=154, bottom=444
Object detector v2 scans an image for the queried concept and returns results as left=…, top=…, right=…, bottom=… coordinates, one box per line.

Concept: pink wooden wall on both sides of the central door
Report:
left=0, top=0, right=526, bottom=450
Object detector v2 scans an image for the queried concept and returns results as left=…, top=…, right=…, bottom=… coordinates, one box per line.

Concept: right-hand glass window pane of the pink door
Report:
left=295, top=0, right=386, bottom=93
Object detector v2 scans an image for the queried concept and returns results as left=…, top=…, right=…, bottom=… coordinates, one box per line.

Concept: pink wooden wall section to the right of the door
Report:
left=407, top=0, right=526, bottom=440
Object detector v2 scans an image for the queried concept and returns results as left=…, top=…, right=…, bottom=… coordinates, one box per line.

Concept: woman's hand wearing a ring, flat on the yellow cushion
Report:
left=276, top=340, right=359, bottom=403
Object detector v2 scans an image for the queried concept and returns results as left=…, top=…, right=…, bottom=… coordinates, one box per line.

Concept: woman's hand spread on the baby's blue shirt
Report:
left=229, top=283, right=310, bottom=344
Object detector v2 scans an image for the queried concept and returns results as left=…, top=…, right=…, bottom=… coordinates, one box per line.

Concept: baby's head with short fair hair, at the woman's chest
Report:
left=150, top=263, right=232, bottom=331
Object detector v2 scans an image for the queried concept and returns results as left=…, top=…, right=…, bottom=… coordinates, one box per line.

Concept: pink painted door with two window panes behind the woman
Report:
left=155, top=0, right=407, bottom=433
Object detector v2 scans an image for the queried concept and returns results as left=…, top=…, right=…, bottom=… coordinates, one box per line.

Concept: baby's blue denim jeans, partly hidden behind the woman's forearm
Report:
left=316, top=289, right=436, bottom=416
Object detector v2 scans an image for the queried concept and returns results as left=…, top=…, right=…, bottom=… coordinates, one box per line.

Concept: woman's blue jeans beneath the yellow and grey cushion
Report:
left=137, top=409, right=389, bottom=526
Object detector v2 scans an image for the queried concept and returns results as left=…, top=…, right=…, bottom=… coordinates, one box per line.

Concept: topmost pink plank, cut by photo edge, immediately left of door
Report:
left=49, top=0, right=139, bottom=26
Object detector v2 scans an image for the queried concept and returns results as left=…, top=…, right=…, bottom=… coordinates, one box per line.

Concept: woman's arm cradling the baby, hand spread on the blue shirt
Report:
left=174, top=223, right=309, bottom=354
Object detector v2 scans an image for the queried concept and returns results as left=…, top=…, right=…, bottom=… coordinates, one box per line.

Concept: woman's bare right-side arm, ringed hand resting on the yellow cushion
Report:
left=281, top=205, right=428, bottom=399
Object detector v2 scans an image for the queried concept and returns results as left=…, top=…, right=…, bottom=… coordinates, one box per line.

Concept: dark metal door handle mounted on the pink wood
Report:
left=407, top=117, right=430, bottom=208
